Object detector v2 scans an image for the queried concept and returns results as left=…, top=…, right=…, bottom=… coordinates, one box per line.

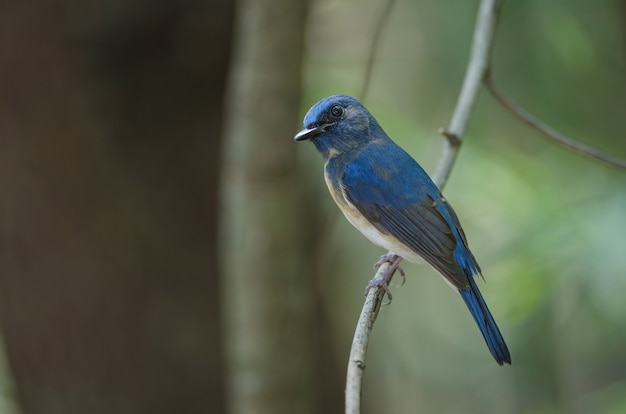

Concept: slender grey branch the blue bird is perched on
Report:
left=345, top=0, right=501, bottom=414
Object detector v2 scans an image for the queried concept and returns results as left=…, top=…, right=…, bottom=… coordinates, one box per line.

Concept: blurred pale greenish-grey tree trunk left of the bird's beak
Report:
left=223, top=0, right=343, bottom=414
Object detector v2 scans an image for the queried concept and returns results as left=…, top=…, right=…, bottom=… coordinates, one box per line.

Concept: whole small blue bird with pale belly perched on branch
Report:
left=294, top=95, right=511, bottom=365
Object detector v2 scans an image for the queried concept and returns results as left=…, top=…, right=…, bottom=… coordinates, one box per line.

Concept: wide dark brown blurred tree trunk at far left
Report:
left=0, top=0, right=233, bottom=414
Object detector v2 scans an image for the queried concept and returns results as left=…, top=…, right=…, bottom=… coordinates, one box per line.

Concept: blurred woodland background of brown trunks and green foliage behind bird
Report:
left=0, top=0, right=626, bottom=414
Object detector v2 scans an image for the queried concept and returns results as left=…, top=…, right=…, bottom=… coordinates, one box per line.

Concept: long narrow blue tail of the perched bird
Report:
left=459, top=276, right=511, bottom=365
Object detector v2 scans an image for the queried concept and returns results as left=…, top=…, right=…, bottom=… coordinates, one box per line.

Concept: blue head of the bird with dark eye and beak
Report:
left=294, top=95, right=386, bottom=159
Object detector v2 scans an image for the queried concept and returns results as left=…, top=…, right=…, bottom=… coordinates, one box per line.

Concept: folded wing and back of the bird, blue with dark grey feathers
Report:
left=341, top=142, right=480, bottom=289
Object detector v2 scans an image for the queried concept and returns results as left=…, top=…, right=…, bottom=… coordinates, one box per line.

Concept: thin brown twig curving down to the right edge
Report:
left=485, top=74, right=626, bottom=169
